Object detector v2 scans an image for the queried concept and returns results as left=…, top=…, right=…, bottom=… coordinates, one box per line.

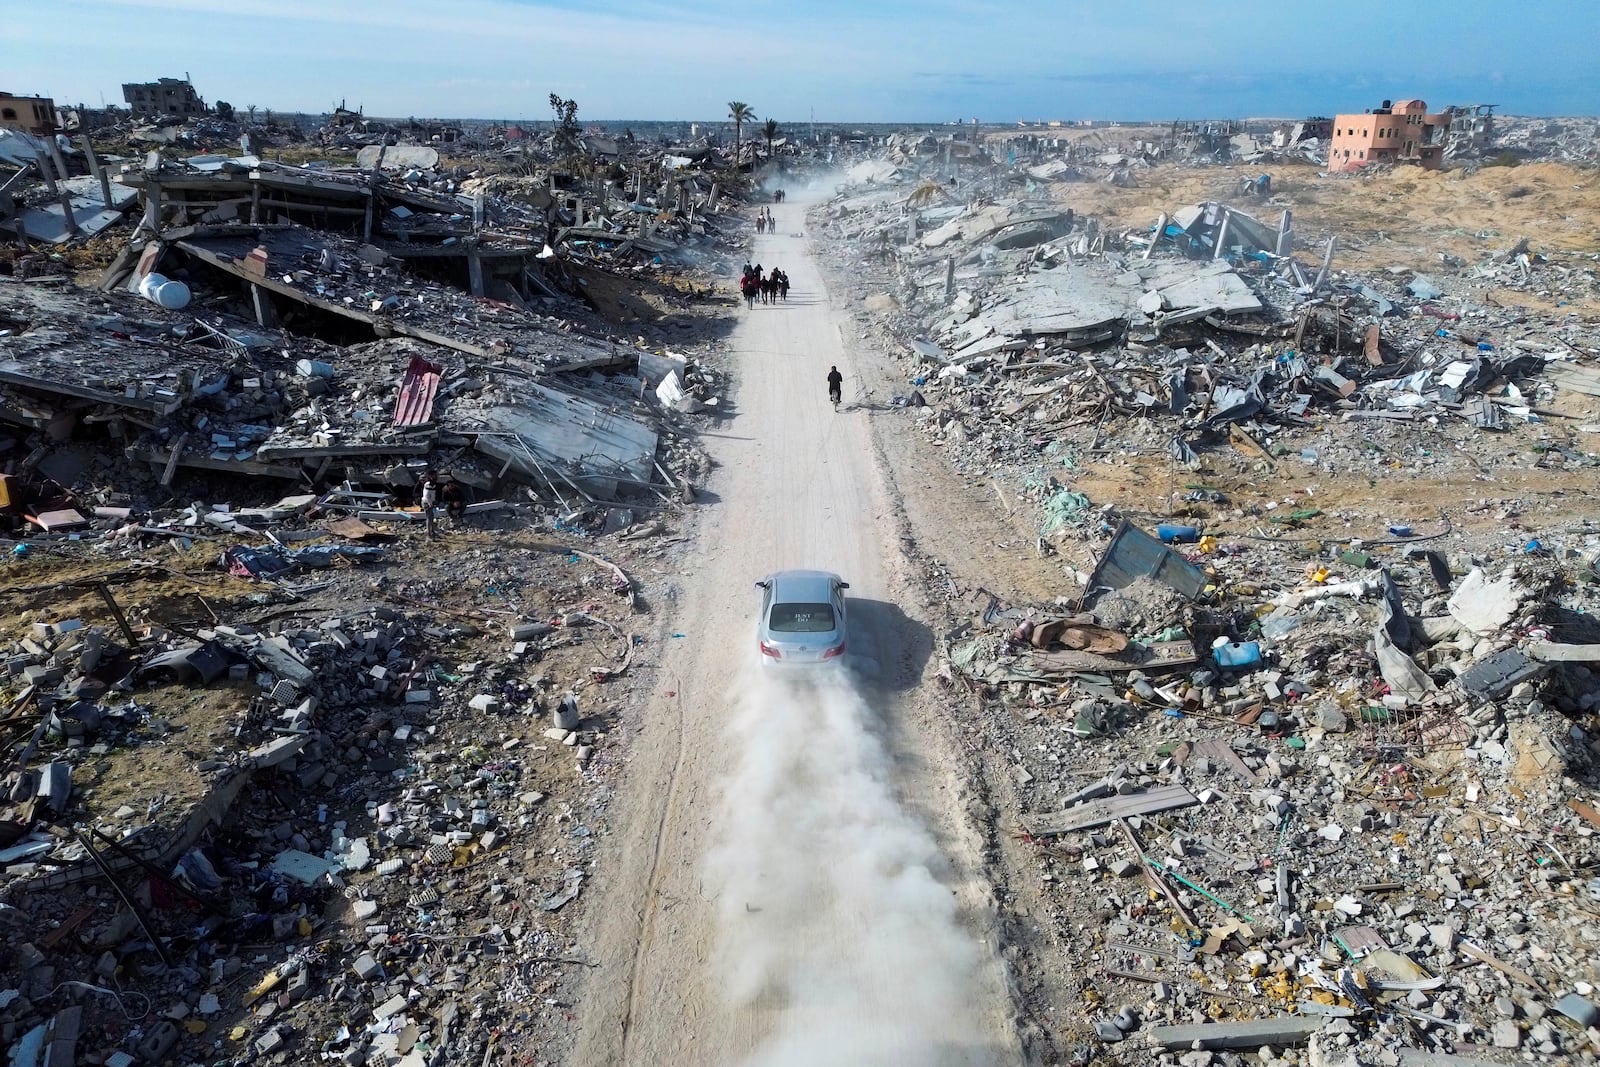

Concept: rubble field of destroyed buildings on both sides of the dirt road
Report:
left=0, top=97, right=1600, bottom=1067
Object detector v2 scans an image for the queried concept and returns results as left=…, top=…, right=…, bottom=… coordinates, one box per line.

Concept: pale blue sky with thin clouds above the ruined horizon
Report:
left=0, top=0, right=1600, bottom=123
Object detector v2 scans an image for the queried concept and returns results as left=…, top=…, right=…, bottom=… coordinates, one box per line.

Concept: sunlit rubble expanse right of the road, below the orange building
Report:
left=813, top=143, right=1600, bottom=1064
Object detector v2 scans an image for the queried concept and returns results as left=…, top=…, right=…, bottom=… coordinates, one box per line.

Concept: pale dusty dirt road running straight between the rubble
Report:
left=573, top=202, right=1021, bottom=1067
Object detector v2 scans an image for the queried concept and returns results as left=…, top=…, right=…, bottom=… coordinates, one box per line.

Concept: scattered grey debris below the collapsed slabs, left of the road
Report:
left=0, top=541, right=659, bottom=1065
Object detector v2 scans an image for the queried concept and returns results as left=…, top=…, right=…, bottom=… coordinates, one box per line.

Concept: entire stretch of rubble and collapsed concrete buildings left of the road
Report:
left=0, top=110, right=806, bottom=1065
